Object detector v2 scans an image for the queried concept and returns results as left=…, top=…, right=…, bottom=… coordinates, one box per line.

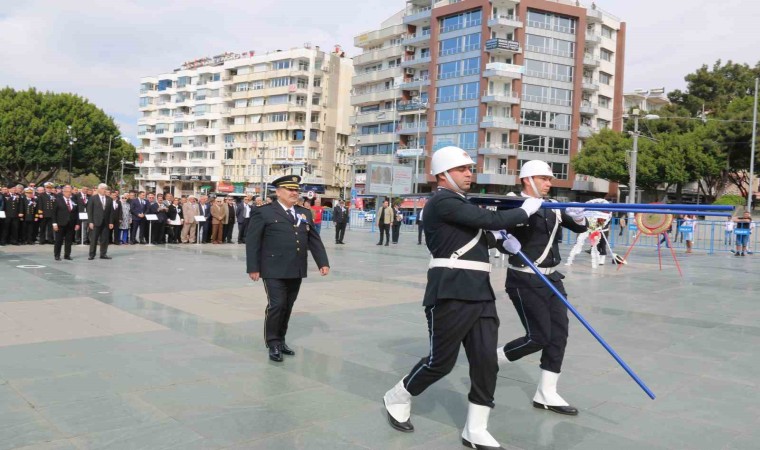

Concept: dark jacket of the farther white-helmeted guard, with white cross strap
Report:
left=506, top=200, right=587, bottom=293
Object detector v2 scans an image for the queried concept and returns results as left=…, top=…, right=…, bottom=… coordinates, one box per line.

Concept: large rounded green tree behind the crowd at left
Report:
left=0, top=88, right=135, bottom=184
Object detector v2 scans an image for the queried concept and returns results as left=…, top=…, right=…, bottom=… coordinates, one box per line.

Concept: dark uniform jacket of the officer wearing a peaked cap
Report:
left=245, top=201, right=330, bottom=278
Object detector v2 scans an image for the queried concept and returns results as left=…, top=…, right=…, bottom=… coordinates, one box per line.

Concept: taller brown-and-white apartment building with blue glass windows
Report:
left=351, top=0, right=625, bottom=200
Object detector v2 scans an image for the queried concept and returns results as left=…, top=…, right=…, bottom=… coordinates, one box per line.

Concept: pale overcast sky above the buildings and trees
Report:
left=0, top=0, right=760, bottom=143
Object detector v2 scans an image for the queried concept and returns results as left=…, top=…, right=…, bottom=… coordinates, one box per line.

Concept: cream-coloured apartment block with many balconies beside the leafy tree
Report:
left=137, top=45, right=353, bottom=198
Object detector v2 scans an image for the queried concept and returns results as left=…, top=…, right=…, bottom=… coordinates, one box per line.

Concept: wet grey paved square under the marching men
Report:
left=0, top=229, right=760, bottom=450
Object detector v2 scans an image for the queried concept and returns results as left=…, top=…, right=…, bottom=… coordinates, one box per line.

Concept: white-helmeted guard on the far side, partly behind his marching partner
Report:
left=497, top=160, right=586, bottom=415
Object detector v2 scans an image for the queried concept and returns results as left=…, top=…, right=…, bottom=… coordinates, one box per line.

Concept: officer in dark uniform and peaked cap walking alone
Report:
left=245, top=175, right=330, bottom=362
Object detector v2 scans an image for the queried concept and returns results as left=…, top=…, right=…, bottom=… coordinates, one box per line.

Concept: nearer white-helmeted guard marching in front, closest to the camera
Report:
left=383, top=147, right=542, bottom=449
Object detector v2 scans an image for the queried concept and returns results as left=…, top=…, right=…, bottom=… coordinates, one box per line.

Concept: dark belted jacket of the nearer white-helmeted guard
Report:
left=422, top=188, right=528, bottom=306
